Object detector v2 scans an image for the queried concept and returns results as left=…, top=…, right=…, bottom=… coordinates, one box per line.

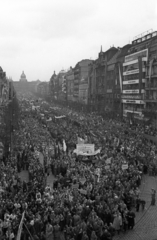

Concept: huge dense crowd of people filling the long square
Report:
left=0, top=93, right=157, bottom=240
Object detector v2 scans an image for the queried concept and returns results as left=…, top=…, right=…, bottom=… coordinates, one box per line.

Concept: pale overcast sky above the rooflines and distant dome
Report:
left=0, top=0, right=157, bottom=81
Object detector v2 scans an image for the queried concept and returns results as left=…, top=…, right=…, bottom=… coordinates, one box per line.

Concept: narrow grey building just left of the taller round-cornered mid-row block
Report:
left=66, top=67, right=74, bottom=101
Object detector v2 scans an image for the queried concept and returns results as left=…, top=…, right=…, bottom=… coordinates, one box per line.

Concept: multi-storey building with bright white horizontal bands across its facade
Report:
left=122, top=30, right=156, bottom=120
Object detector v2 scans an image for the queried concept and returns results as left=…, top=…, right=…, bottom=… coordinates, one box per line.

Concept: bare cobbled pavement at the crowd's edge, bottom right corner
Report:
left=113, top=175, right=157, bottom=240
